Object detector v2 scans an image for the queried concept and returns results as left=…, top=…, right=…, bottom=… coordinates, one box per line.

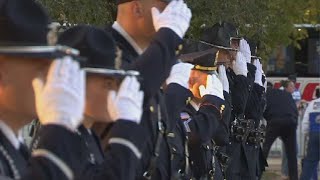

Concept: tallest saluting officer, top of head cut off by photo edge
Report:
left=92, top=0, right=191, bottom=179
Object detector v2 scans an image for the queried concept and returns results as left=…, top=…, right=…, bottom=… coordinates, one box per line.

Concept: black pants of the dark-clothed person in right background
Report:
left=263, top=121, right=298, bottom=180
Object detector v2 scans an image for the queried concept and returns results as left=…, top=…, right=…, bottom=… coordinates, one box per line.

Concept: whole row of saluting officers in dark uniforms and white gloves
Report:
left=0, top=0, right=266, bottom=180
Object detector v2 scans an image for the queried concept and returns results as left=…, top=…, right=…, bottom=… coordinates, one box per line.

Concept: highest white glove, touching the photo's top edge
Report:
left=151, top=0, right=192, bottom=38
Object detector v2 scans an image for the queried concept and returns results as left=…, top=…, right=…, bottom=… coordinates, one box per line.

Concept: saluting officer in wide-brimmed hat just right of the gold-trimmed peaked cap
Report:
left=191, top=22, right=250, bottom=179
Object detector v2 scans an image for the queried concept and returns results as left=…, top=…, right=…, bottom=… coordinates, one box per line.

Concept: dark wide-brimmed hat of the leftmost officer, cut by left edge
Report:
left=0, top=0, right=78, bottom=59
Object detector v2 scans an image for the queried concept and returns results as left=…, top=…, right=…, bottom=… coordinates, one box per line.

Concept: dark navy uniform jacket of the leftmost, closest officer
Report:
left=0, top=125, right=84, bottom=180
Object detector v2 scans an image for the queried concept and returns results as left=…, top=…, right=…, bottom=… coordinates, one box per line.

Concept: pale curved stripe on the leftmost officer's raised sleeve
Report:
left=32, top=149, right=74, bottom=180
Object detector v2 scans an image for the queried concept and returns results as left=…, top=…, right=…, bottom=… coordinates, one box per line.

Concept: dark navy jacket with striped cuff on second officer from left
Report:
left=78, top=120, right=147, bottom=180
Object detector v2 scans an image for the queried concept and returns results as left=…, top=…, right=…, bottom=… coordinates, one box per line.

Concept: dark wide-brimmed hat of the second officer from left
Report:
left=58, top=25, right=139, bottom=77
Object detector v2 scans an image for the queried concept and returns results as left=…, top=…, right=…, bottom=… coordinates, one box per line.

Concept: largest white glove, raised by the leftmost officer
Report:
left=32, top=57, right=85, bottom=130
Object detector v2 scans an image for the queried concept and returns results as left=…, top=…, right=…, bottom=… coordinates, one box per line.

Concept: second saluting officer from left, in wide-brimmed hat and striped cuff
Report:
left=36, top=25, right=147, bottom=180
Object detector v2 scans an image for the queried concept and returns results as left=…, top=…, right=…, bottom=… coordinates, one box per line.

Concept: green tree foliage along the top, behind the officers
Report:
left=38, top=0, right=320, bottom=60
